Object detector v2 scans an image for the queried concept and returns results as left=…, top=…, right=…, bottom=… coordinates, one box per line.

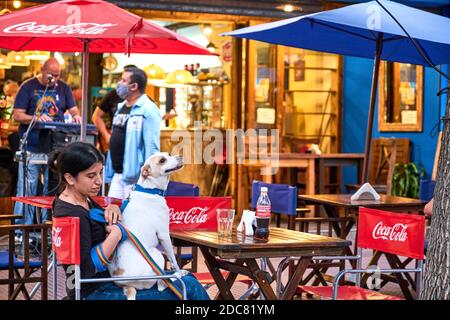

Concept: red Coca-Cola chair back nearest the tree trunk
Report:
left=357, top=207, right=425, bottom=260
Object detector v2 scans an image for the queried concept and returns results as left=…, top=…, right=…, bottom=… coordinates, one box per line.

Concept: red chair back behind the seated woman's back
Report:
left=52, top=217, right=80, bottom=264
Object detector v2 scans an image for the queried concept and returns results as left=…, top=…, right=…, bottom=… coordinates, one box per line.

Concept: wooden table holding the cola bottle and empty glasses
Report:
left=171, top=228, right=351, bottom=300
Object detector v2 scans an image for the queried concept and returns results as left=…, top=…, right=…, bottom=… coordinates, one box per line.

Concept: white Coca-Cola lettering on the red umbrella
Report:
left=3, top=22, right=117, bottom=34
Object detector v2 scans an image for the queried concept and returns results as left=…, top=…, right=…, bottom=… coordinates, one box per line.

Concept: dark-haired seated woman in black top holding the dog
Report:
left=49, top=142, right=209, bottom=300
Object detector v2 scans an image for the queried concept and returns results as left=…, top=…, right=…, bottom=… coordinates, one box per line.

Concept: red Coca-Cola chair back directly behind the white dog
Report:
left=166, top=197, right=231, bottom=231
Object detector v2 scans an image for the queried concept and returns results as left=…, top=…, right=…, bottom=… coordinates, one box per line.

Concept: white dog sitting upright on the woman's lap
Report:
left=109, top=152, right=187, bottom=300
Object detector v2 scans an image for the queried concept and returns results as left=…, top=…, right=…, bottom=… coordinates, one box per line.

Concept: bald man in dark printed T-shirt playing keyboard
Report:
left=13, top=58, right=81, bottom=235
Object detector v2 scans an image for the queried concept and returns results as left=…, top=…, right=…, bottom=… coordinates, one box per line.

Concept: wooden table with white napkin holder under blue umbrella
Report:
left=298, top=194, right=426, bottom=299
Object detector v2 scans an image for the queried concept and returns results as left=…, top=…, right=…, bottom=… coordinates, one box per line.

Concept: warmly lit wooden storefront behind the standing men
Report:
left=0, top=1, right=341, bottom=205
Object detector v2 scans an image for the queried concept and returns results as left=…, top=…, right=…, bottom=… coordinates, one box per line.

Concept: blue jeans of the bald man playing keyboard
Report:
left=14, top=154, right=48, bottom=233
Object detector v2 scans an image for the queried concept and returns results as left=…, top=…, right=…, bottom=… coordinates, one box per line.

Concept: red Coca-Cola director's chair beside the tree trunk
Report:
left=279, top=207, right=425, bottom=300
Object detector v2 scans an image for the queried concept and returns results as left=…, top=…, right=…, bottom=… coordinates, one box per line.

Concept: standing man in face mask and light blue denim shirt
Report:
left=106, top=67, right=162, bottom=199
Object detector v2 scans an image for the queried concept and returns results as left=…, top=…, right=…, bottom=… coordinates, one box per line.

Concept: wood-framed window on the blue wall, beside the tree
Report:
left=378, top=62, right=423, bottom=131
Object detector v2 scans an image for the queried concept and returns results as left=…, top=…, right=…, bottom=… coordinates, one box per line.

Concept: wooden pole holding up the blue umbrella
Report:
left=361, top=32, right=383, bottom=183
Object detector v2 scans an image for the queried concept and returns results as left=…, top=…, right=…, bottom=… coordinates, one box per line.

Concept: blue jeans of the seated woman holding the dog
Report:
left=84, top=273, right=210, bottom=300
